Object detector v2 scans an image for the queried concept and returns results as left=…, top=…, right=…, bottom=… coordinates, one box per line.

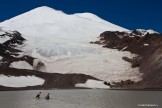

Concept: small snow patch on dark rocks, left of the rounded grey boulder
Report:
left=9, top=61, right=33, bottom=70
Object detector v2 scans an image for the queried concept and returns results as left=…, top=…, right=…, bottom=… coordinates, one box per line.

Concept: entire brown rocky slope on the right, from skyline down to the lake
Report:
left=91, top=30, right=162, bottom=89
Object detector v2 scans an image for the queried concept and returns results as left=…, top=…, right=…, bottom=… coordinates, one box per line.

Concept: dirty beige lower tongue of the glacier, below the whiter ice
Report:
left=40, top=48, right=142, bottom=82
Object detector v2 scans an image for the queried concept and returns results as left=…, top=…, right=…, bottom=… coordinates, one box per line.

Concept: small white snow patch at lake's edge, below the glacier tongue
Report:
left=75, top=79, right=110, bottom=89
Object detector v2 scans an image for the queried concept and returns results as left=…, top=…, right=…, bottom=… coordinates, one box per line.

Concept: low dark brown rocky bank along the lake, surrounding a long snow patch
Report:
left=0, top=67, right=98, bottom=91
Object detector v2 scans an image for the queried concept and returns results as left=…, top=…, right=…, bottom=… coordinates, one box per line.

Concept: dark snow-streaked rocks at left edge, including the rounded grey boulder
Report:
left=0, top=29, right=46, bottom=71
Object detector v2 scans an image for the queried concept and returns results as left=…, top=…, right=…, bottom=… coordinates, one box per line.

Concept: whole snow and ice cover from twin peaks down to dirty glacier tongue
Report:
left=0, top=6, right=142, bottom=88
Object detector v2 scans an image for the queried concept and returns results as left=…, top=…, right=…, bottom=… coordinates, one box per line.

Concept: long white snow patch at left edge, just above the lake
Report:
left=0, top=75, right=45, bottom=87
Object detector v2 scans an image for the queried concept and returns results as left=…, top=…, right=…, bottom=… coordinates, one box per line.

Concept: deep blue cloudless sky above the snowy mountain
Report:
left=0, top=0, right=162, bottom=33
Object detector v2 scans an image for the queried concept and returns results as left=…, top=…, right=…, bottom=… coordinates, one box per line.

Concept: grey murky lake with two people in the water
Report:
left=0, top=89, right=162, bottom=108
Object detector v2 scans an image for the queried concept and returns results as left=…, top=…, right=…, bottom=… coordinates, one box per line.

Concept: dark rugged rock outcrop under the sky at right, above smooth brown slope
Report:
left=94, top=30, right=162, bottom=56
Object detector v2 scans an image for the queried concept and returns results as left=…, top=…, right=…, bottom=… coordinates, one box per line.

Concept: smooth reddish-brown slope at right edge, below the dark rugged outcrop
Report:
left=137, top=45, right=162, bottom=89
